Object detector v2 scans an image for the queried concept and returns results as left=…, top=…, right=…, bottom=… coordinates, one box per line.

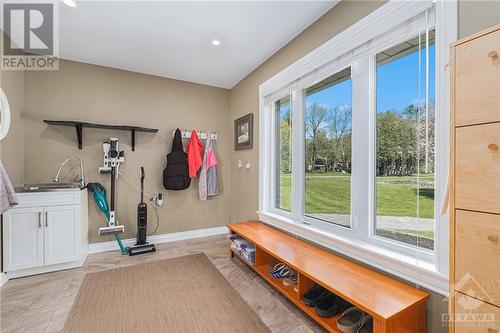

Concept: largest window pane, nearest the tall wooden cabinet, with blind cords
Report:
left=375, top=31, right=435, bottom=249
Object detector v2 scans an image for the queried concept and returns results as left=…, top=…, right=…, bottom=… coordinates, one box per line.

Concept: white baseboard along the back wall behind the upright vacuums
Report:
left=89, top=226, right=228, bottom=254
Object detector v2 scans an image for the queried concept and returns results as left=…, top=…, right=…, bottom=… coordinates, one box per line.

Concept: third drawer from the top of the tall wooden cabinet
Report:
left=455, top=210, right=500, bottom=304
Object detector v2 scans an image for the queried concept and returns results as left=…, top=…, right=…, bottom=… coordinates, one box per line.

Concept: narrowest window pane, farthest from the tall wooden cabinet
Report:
left=275, top=97, right=292, bottom=211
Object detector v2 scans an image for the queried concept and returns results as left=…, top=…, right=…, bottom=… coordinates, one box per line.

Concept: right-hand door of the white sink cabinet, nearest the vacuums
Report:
left=44, top=206, right=81, bottom=265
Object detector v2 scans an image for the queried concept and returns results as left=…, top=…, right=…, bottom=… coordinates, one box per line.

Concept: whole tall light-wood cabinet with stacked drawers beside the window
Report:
left=450, top=25, right=500, bottom=333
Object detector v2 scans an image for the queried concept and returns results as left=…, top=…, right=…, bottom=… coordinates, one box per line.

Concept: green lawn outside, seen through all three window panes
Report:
left=280, top=172, right=434, bottom=218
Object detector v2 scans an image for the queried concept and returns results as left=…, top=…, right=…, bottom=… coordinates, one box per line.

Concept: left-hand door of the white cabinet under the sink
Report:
left=3, top=208, right=44, bottom=272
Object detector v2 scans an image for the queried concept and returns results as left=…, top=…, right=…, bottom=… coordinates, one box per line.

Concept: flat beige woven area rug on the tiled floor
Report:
left=63, top=254, right=270, bottom=333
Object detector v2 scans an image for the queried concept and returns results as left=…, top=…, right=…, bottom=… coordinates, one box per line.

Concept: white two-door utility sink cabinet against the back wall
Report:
left=3, top=190, right=88, bottom=277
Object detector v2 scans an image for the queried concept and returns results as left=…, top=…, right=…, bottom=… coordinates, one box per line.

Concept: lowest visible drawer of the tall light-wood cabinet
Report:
left=454, top=293, right=500, bottom=333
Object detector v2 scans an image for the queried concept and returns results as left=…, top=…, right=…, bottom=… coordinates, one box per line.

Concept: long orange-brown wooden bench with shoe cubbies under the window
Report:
left=228, top=221, right=429, bottom=333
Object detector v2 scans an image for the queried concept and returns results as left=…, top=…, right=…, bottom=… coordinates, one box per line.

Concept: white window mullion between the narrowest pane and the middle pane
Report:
left=291, top=83, right=305, bottom=221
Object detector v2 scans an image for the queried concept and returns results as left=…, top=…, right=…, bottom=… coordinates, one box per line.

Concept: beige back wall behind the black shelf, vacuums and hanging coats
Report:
left=23, top=61, right=231, bottom=243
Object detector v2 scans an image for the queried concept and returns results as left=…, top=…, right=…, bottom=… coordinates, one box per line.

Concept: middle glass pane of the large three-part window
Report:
left=305, top=68, right=352, bottom=227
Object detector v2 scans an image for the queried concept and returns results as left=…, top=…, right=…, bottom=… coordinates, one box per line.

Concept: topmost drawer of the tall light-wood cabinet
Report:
left=455, top=31, right=500, bottom=126
